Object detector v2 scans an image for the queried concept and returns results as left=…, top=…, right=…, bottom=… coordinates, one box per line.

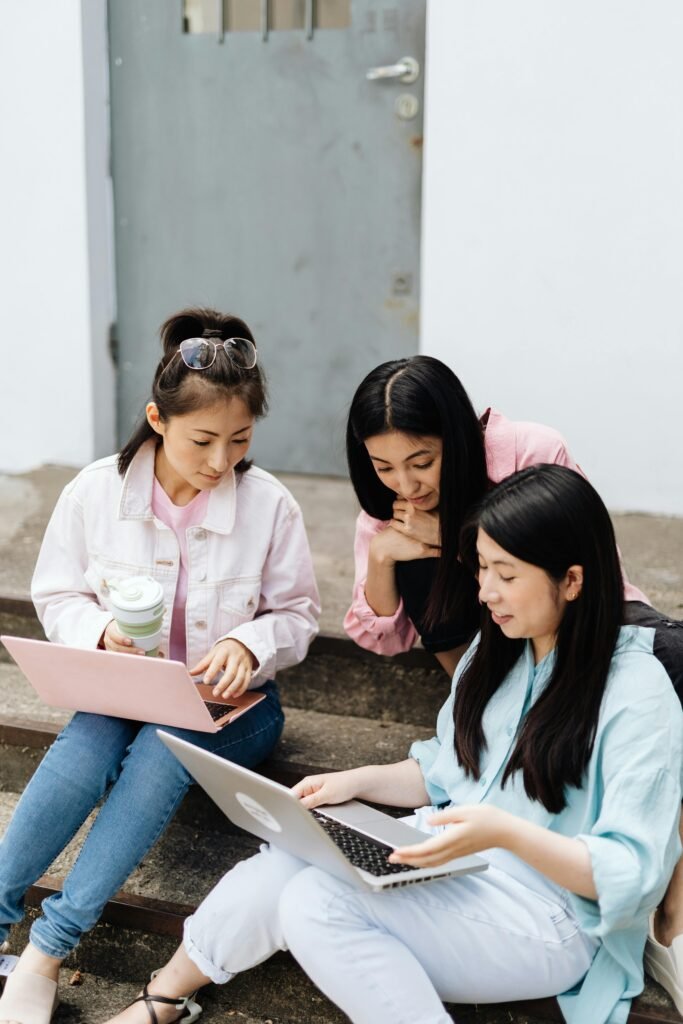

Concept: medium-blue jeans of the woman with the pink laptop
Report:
left=0, top=682, right=285, bottom=958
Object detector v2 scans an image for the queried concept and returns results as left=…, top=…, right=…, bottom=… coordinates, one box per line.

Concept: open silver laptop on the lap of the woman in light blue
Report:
left=157, top=729, right=487, bottom=891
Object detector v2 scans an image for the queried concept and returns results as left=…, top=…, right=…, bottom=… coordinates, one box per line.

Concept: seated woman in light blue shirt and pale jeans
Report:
left=104, top=466, right=683, bottom=1024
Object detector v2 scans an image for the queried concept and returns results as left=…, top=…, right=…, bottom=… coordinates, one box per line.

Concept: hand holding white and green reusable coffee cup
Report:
left=102, top=577, right=164, bottom=657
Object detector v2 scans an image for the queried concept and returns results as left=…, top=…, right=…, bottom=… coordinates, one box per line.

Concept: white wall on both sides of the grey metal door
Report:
left=0, top=0, right=683, bottom=515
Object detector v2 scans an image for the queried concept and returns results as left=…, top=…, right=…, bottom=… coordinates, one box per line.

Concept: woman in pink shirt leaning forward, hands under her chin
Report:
left=344, top=355, right=683, bottom=1013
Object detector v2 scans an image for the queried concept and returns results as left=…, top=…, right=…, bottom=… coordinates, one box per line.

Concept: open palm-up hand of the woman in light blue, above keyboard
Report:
left=389, top=804, right=516, bottom=867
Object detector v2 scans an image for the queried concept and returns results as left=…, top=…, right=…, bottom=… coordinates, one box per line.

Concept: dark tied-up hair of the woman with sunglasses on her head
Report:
left=117, top=306, right=268, bottom=476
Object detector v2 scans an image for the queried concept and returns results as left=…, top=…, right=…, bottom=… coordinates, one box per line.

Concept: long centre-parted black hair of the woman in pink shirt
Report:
left=346, top=355, right=488, bottom=626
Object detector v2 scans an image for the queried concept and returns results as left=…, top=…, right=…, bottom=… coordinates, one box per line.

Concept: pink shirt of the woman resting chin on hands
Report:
left=344, top=409, right=649, bottom=654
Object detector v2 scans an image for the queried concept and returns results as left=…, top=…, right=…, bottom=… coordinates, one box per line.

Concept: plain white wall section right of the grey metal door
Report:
left=422, top=0, right=683, bottom=515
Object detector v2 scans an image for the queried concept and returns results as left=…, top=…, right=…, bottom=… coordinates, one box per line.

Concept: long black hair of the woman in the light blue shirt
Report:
left=454, top=465, right=624, bottom=813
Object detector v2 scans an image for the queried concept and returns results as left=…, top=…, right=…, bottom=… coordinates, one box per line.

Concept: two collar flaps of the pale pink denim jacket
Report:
left=118, top=439, right=238, bottom=534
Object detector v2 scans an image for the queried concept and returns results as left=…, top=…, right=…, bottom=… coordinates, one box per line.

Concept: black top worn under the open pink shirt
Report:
left=395, top=558, right=479, bottom=654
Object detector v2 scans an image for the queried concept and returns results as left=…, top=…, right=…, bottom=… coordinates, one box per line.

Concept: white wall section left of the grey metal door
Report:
left=0, top=0, right=114, bottom=471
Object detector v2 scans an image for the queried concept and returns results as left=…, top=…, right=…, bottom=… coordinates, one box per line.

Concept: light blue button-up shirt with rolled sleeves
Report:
left=411, top=626, right=683, bottom=1024
